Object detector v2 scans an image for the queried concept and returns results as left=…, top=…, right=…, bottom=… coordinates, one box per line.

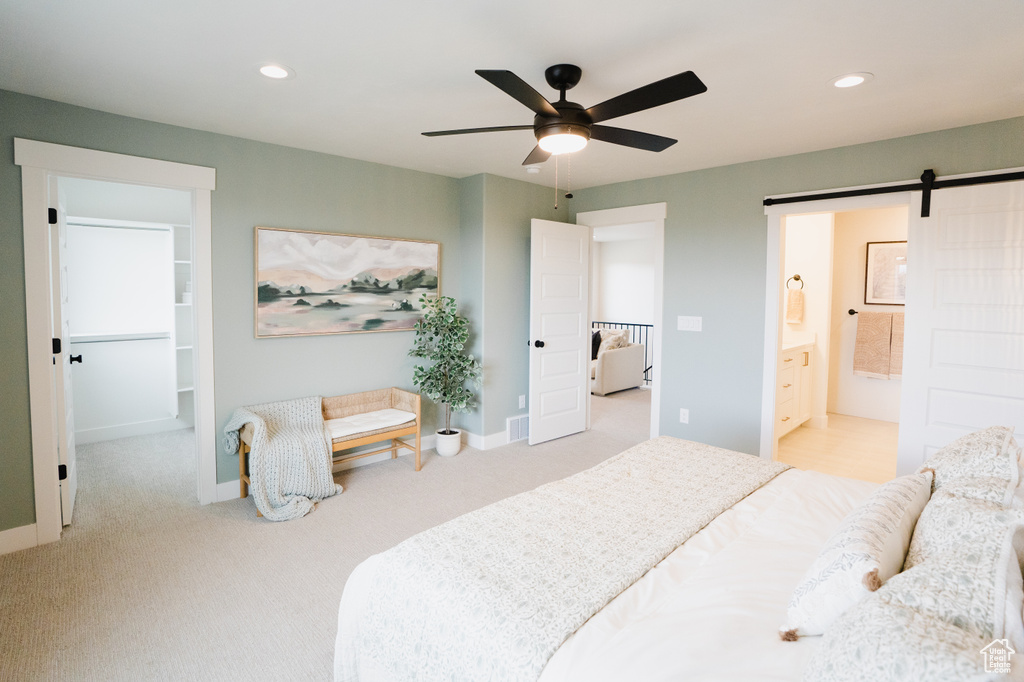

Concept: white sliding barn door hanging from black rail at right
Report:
left=898, top=182, right=1024, bottom=474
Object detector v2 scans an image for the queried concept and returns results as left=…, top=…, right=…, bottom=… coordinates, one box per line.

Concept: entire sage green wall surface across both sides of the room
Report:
left=8, top=84, right=1024, bottom=530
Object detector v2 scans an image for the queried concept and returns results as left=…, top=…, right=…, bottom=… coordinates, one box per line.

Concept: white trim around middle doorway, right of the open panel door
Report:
left=577, top=202, right=669, bottom=438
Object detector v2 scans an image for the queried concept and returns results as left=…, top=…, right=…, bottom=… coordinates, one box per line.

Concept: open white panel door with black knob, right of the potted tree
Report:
left=529, top=219, right=591, bottom=445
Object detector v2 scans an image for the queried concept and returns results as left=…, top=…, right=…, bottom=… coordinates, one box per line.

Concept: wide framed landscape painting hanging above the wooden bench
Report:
left=255, top=227, right=440, bottom=338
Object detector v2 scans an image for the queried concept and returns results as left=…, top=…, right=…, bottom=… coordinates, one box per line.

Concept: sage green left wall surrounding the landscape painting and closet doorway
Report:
left=0, top=91, right=461, bottom=530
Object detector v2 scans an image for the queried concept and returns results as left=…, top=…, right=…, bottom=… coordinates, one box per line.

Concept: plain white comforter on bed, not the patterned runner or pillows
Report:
left=335, top=470, right=876, bottom=682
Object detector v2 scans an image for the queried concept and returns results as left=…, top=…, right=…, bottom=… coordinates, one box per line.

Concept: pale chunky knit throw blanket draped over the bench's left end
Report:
left=224, top=395, right=342, bottom=521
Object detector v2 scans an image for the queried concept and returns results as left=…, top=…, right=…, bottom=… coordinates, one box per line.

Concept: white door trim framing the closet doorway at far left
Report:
left=14, top=138, right=217, bottom=545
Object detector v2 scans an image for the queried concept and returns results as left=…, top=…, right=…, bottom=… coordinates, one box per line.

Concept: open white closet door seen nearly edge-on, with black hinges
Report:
left=49, top=176, right=82, bottom=525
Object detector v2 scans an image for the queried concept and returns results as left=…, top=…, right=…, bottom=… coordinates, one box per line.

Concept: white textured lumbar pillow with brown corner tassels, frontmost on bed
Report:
left=779, top=471, right=932, bottom=641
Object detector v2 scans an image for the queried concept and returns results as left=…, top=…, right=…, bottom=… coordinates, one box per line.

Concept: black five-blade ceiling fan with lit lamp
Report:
left=423, top=63, right=708, bottom=166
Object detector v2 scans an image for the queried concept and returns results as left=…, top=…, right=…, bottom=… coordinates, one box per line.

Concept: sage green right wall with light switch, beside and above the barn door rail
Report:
left=571, top=118, right=1024, bottom=454
